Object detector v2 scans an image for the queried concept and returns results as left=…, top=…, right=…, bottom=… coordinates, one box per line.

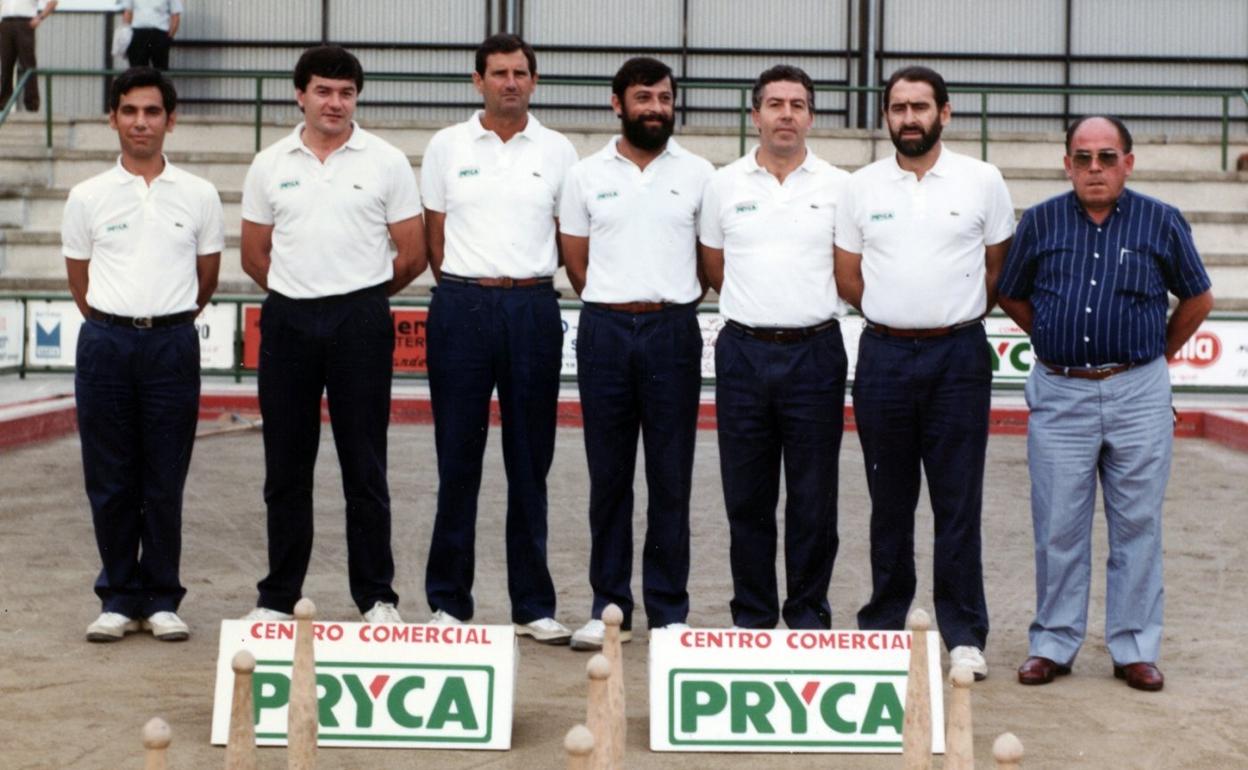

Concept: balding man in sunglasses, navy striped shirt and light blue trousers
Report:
left=998, top=116, right=1213, bottom=690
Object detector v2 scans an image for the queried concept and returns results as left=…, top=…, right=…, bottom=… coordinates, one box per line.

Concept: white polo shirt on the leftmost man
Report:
left=61, top=158, right=226, bottom=317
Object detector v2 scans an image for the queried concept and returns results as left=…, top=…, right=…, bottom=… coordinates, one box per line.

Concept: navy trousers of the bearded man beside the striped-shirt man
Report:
left=854, top=324, right=992, bottom=649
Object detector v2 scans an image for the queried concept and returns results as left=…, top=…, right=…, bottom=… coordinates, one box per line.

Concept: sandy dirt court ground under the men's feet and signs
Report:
left=0, top=426, right=1248, bottom=770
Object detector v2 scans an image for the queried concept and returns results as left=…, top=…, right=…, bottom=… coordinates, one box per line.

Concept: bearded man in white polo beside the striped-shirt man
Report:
left=836, top=66, right=1013, bottom=679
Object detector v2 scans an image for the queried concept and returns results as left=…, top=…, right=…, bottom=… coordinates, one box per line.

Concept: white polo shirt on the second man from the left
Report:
left=242, top=122, right=421, bottom=300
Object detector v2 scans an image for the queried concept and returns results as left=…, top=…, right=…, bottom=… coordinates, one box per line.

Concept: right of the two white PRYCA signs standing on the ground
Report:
left=650, top=629, right=945, bottom=754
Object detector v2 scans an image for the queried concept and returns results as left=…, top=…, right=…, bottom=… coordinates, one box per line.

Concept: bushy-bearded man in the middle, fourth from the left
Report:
left=559, top=56, right=713, bottom=650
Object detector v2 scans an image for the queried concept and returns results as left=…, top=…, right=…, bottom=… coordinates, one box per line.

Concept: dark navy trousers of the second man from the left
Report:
left=257, top=286, right=398, bottom=613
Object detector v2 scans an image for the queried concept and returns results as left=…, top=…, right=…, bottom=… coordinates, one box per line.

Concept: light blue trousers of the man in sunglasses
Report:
left=1026, top=358, right=1174, bottom=665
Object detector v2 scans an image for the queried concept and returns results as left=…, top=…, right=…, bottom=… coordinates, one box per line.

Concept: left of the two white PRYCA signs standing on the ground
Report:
left=212, top=620, right=518, bottom=749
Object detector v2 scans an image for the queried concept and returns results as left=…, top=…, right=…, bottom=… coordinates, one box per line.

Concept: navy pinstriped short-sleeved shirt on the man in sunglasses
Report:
left=998, top=190, right=1211, bottom=367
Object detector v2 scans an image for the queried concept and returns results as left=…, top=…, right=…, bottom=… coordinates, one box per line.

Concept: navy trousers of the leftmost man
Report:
left=74, top=321, right=200, bottom=618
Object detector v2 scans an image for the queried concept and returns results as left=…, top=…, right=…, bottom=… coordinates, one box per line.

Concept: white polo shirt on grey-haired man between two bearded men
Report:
left=699, top=146, right=849, bottom=327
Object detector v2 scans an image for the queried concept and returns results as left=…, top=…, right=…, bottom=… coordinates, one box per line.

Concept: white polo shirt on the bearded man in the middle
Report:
left=559, top=137, right=715, bottom=303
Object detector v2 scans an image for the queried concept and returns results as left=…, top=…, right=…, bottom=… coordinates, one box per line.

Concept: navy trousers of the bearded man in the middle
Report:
left=577, top=305, right=703, bottom=629
